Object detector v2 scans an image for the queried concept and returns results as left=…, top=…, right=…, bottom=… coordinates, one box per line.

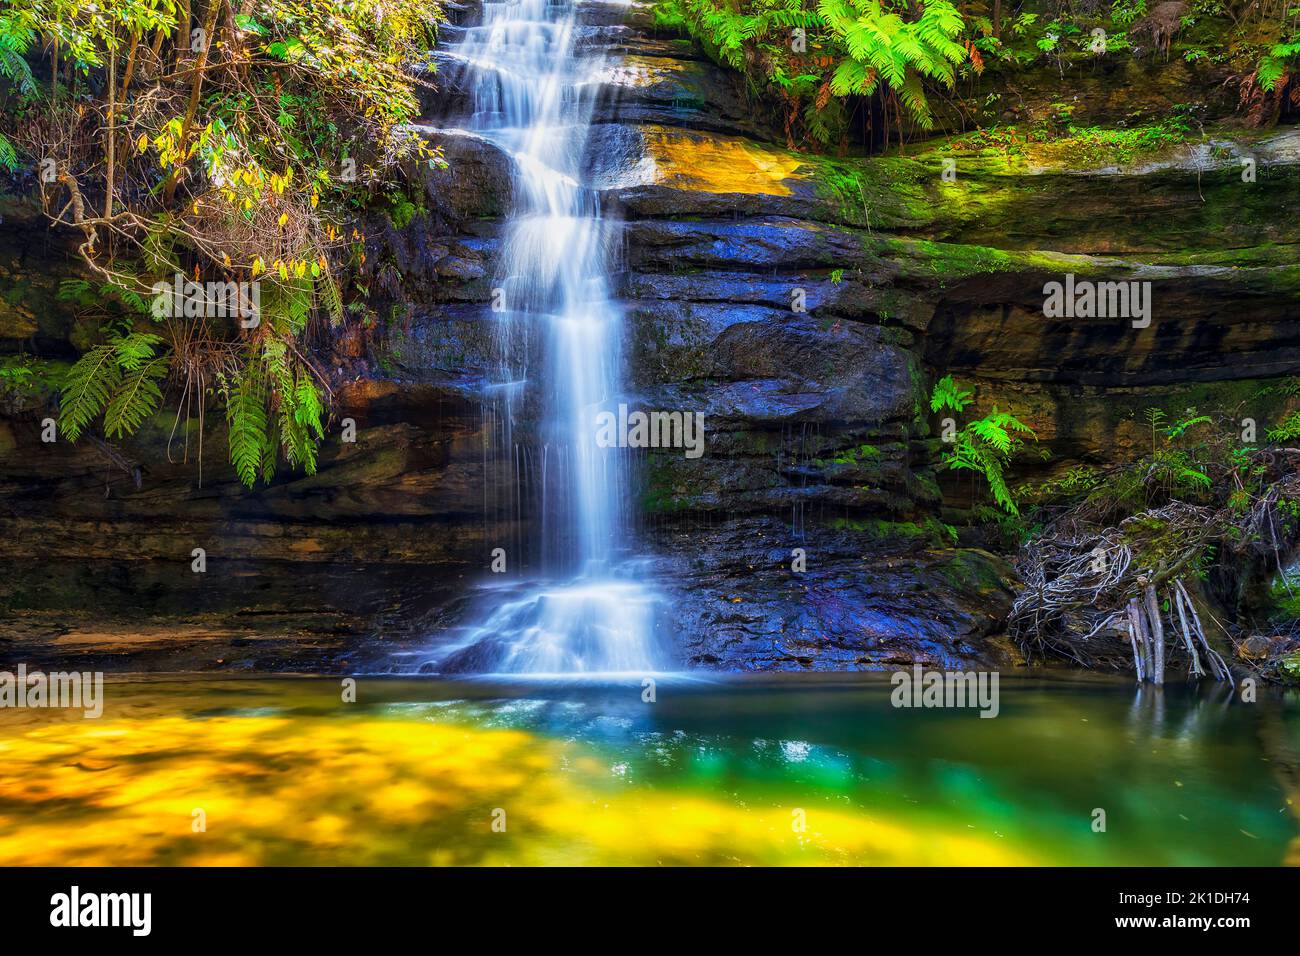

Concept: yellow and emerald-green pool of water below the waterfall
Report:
left=0, top=675, right=1300, bottom=865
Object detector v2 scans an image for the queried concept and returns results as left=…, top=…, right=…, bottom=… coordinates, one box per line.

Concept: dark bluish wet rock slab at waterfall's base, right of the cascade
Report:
left=644, top=519, right=1015, bottom=670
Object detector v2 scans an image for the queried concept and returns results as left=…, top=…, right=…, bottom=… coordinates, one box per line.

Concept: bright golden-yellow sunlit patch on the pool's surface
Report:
left=0, top=711, right=1041, bottom=865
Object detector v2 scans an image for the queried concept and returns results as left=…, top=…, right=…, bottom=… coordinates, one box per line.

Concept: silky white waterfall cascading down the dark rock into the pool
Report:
left=421, top=0, right=662, bottom=674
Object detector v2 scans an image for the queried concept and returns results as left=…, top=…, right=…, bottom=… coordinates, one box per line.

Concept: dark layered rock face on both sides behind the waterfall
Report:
left=0, top=3, right=1300, bottom=670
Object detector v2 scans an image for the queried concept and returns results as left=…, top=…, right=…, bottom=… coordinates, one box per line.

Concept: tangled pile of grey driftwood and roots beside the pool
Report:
left=1008, top=434, right=1300, bottom=684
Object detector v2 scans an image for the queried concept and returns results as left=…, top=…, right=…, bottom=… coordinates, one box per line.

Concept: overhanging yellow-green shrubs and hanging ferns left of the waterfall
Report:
left=0, top=0, right=443, bottom=486
